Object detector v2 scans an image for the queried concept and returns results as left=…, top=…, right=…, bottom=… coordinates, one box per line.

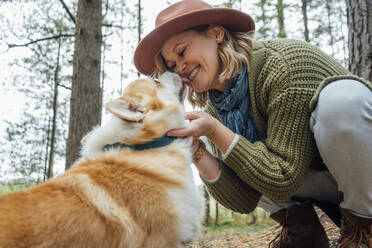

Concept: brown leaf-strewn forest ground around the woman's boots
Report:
left=191, top=209, right=339, bottom=248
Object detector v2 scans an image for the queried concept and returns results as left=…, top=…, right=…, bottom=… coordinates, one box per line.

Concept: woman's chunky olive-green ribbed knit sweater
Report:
left=203, top=39, right=372, bottom=213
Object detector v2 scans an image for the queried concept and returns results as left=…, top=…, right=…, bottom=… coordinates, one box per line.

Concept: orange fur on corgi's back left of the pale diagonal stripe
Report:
left=0, top=172, right=126, bottom=248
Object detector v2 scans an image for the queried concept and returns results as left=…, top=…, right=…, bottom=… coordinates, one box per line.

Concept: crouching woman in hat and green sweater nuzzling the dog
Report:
left=134, top=0, right=372, bottom=248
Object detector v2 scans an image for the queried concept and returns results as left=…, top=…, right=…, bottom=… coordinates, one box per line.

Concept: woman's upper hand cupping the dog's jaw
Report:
left=167, top=111, right=219, bottom=138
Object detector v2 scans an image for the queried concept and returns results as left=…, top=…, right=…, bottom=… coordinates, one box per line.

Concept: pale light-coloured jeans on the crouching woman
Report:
left=258, top=79, right=372, bottom=217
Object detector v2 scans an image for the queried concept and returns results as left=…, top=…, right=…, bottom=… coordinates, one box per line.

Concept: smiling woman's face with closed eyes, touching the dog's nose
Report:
left=161, top=26, right=223, bottom=93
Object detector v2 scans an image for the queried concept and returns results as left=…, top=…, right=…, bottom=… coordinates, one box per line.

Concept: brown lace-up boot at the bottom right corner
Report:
left=338, top=209, right=372, bottom=248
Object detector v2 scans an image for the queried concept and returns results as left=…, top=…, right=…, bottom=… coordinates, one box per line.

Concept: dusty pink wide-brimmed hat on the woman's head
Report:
left=134, top=0, right=255, bottom=75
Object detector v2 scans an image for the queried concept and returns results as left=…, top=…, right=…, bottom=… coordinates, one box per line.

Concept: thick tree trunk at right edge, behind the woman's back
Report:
left=346, top=0, right=372, bottom=81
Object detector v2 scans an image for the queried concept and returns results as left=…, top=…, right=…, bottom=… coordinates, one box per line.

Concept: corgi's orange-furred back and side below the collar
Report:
left=0, top=148, right=192, bottom=248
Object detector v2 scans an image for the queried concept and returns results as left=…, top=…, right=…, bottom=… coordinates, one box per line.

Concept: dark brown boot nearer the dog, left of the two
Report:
left=269, top=202, right=329, bottom=248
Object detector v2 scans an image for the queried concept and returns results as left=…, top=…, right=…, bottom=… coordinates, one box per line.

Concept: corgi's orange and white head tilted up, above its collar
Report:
left=105, top=72, right=185, bottom=145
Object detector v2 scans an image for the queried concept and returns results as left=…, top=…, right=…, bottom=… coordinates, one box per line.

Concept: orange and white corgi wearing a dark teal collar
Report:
left=0, top=72, right=203, bottom=248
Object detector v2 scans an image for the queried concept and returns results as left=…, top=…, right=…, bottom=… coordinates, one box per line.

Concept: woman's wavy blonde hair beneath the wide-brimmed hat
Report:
left=153, top=25, right=254, bottom=107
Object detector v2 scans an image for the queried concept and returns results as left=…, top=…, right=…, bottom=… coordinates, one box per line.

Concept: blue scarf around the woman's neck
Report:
left=208, top=65, right=259, bottom=143
